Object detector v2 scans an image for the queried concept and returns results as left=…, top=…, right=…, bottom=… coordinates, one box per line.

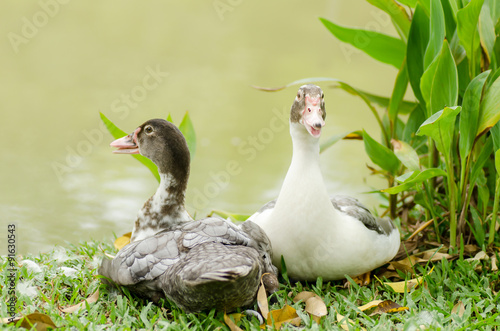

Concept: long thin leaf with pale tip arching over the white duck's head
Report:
left=253, top=77, right=417, bottom=114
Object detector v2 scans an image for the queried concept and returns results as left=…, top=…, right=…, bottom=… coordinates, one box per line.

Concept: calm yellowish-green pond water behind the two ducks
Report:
left=0, top=0, right=396, bottom=254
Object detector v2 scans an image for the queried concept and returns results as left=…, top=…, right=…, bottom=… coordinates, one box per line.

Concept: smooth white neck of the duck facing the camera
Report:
left=277, top=122, right=329, bottom=208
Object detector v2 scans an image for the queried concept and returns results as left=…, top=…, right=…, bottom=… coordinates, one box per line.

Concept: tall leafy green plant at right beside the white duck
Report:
left=268, top=0, right=500, bottom=247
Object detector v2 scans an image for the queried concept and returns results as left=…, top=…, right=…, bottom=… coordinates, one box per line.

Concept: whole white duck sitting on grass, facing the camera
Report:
left=249, top=84, right=400, bottom=280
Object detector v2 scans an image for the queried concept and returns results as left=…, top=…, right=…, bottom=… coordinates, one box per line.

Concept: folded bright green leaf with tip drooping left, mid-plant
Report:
left=417, top=106, right=462, bottom=158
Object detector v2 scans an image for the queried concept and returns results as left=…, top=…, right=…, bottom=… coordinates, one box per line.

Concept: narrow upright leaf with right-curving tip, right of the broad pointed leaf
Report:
left=459, top=71, right=490, bottom=160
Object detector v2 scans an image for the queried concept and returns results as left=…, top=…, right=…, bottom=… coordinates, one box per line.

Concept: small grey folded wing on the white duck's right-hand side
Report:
left=331, top=195, right=395, bottom=235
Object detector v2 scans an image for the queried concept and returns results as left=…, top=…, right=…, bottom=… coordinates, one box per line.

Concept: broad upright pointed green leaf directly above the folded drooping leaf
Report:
left=420, top=40, right=458, bottom=116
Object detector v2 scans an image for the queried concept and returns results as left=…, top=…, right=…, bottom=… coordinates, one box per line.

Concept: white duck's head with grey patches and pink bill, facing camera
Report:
left=290, top=84, right=326, bottom=138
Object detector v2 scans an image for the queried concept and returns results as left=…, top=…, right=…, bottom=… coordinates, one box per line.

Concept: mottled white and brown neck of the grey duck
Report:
left=131, top=173, right=192, bottom=241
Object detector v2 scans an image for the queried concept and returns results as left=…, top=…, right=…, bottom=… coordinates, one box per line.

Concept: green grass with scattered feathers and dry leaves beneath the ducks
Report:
left=0, top=242, right=500, bottom=330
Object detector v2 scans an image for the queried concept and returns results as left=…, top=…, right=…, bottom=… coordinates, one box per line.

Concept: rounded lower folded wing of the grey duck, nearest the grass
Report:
left=160, top=242, right=263, bottom=312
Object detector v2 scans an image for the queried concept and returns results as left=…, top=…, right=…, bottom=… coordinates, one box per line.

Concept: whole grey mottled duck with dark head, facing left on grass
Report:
left=99, top=120, right=277, bottom=312
